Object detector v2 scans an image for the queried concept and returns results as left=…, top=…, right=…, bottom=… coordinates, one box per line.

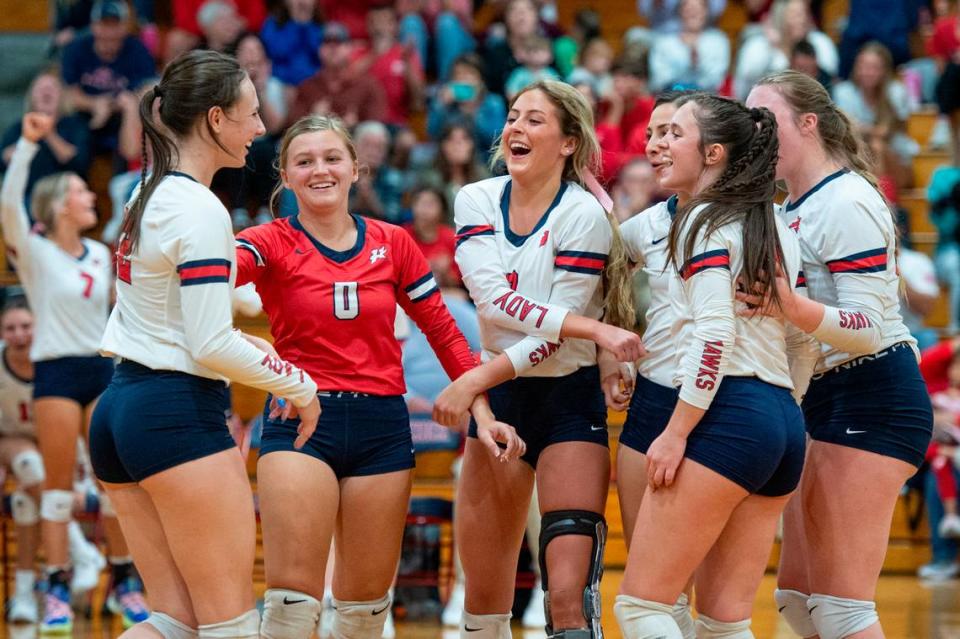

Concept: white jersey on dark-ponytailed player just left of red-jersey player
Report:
left=101, top=173, right=317, bottom=406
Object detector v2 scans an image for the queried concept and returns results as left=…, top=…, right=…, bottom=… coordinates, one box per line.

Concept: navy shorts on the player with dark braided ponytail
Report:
left=684, top=377, right=807, bottom=497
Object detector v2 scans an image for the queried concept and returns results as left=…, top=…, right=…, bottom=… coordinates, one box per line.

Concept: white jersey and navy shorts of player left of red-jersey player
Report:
left=90, top=173, right=317, bottom=483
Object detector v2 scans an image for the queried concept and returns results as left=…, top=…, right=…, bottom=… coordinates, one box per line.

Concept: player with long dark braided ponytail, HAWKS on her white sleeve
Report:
left=614, top=94, right=804, bottom=639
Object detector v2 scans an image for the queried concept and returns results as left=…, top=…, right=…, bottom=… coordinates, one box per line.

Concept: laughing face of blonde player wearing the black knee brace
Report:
left=500, top=89, right=576, bottom=184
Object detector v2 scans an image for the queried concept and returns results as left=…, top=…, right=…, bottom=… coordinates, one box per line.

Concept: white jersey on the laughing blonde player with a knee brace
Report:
left=454, top=176, right=613, bottom=377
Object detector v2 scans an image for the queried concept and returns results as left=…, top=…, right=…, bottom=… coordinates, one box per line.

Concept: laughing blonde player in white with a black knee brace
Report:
left=434, top=81, right=643, bottom=639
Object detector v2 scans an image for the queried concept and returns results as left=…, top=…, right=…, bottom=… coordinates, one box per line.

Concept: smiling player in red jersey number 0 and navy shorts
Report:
left=237, top=116, right=523, bottom=639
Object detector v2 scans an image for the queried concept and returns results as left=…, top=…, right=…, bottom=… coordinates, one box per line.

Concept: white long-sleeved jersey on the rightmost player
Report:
left=780, top=169, right=919, bottom=372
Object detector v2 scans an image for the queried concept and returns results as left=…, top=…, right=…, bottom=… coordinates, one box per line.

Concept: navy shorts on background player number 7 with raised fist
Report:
left=33, top=355, right=113, bottom=406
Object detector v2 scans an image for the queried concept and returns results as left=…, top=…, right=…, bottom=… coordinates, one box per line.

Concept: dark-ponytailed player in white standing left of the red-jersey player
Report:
left=90, top=51, right=320, bottom=639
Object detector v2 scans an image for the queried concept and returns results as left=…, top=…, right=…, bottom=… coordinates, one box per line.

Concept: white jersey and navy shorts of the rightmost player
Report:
left=781, top=169, right=933, bottom=466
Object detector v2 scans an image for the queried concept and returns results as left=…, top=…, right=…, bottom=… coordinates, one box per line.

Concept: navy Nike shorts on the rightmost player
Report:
left=803, top=342, right=933, bottom=468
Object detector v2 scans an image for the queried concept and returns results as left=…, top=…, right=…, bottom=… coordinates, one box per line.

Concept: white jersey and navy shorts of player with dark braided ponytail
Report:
left=670, top=205, right=811, bottom=496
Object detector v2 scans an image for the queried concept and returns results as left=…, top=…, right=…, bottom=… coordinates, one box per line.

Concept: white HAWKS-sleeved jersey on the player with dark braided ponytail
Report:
left=670, top=205, right=809, bottom=409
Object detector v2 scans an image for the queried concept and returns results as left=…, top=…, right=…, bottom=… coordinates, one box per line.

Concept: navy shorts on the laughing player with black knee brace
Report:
left=467, top=366, right=609, bottom=468
